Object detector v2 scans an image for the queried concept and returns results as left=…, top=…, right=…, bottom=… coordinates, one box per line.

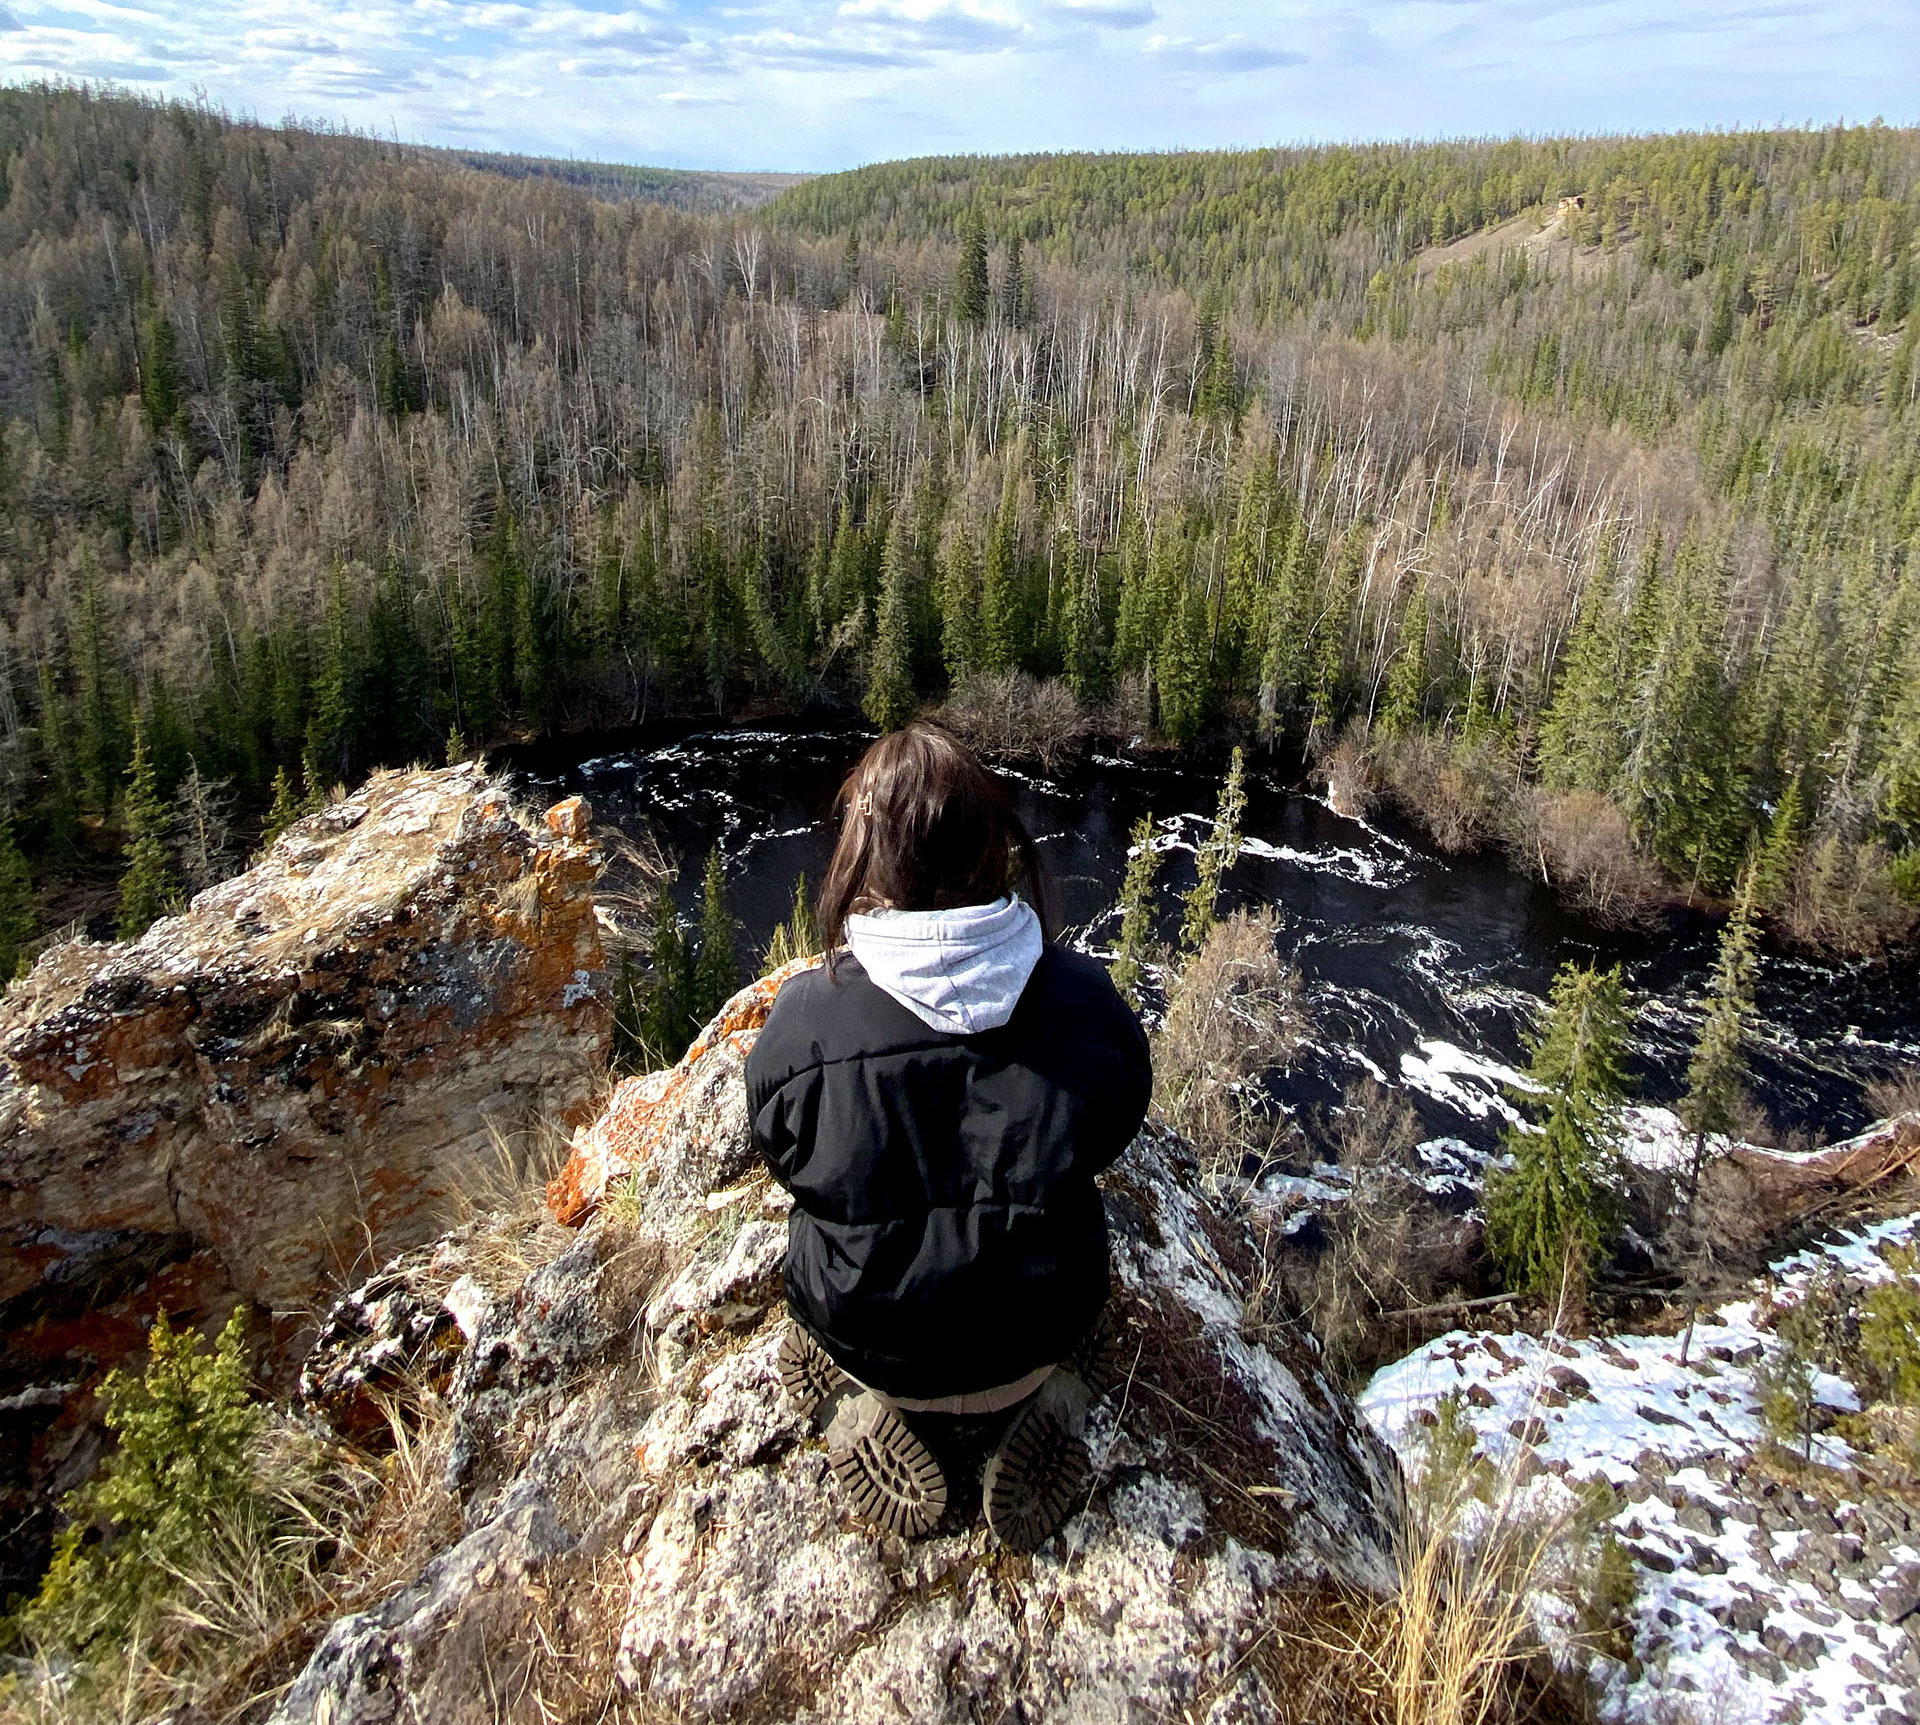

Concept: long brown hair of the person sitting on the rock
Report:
left=820, top=718, right=1052, bottom=966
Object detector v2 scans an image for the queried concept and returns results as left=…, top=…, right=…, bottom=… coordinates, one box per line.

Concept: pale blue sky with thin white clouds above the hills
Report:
left=0, top=0, right=1920, bottom=169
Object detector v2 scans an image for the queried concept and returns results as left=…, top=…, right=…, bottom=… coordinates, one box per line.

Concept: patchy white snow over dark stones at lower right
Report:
left=1361, top=1214, right=1920, bottom=1725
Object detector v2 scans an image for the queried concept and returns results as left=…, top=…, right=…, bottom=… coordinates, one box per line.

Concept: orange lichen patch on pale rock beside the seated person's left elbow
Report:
left=547, top=959, right=820, bottom=1227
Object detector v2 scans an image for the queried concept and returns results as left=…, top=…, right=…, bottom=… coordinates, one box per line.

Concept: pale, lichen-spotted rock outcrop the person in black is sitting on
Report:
left=276, top=982, right=1398, bottom=1725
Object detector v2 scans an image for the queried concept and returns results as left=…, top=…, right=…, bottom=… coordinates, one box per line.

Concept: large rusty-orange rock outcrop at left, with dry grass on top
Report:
left=0, top=765, right=611, bottom=1590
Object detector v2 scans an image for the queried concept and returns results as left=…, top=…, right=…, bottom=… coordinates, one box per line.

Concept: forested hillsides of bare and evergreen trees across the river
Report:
left=0, top=88, right=1920, bottom=951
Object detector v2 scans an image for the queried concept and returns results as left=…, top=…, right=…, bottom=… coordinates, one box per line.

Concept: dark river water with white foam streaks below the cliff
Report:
left=524, top=730, right=1920, bottom=1147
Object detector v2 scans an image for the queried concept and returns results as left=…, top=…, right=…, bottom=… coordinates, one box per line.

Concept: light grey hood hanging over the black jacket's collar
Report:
left=847, top=897, right=1041, bottom=1035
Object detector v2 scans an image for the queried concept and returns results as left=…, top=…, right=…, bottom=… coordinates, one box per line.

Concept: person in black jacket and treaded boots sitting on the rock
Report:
left=747, top=722, right=1152, bottom=1550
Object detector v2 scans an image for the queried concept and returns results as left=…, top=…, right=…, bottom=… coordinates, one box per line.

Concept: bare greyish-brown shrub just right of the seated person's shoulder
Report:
left=1154, top=911, right=1306, bottom=1179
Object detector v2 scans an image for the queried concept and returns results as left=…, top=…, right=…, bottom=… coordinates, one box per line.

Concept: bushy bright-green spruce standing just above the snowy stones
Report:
left=1486, top=964, right=1630, bottom=1299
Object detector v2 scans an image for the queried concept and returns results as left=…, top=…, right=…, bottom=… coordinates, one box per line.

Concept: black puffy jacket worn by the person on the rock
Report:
left=747, top=945, right=1152, bottom=1397
